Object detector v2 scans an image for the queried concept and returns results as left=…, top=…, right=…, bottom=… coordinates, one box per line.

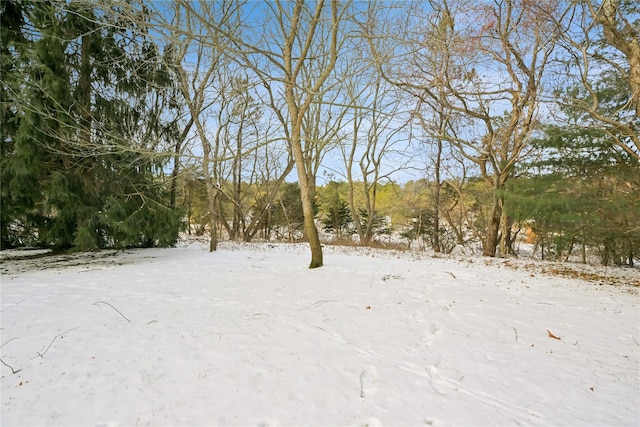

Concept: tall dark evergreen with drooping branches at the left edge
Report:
left=2, top=1, right=182, bottom=250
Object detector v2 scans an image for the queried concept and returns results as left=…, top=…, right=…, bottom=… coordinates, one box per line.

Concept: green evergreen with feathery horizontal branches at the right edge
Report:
left=506, top=72, right=640, bottom=265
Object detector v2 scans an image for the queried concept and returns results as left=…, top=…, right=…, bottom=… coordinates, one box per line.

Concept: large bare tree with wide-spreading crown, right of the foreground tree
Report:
left=371, top=0, right=558, bottom=256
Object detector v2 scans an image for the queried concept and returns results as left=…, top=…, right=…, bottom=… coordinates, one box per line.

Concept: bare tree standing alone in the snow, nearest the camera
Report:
left=196, top=0, right=348, bottom=268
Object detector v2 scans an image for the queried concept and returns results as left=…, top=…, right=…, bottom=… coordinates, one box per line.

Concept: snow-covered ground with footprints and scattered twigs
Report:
left=0, top=239, right=640, bottom=426
